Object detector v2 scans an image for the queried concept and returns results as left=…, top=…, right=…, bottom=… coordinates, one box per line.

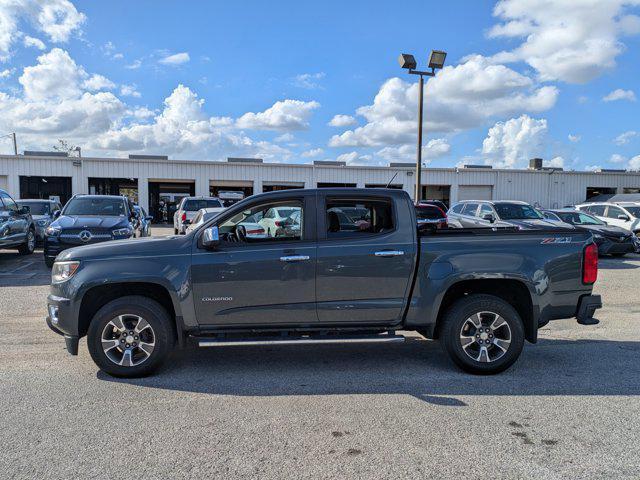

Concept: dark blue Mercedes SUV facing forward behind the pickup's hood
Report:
left=44, top=195, right=136, bottom=268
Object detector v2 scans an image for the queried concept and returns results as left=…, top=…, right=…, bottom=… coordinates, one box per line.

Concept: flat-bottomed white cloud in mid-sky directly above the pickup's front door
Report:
left=236, top=99, right=320, bottom=130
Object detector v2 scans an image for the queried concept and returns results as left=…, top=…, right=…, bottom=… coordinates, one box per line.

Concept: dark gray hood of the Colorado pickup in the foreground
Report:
left=58, top=235, right=192, bottom=263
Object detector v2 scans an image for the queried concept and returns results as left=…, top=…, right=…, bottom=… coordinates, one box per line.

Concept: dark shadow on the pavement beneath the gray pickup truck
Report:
left=97, top=338, right=640, bottom=407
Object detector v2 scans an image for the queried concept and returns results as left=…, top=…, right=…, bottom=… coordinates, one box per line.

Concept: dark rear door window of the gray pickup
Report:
left=325, top=199, right=395, bottom=238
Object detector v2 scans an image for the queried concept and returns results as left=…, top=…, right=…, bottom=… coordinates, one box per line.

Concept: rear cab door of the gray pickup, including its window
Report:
left=316, top=193, right=417, bottom=324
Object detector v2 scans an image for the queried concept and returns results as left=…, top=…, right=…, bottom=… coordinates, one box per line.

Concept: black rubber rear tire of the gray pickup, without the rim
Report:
left=440, top=294, right=524, bottom=375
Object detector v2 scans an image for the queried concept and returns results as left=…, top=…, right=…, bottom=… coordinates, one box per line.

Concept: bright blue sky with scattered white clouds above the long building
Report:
left=0, top=0, right=640, bottom=170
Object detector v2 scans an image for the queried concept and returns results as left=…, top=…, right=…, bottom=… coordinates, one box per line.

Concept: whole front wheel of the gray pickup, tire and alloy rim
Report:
left=87, top=296, right=175, bottom=378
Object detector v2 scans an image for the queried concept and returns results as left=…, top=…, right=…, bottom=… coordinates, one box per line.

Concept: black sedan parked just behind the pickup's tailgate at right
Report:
left=547, top=209, right=637, bottom=257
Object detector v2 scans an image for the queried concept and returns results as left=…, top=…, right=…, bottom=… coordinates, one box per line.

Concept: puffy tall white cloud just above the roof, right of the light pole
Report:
left=482, top=115, right=547, bottom=168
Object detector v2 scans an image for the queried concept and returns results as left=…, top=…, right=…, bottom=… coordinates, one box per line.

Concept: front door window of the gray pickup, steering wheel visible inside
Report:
left=219, top=201, right=304, bottom=243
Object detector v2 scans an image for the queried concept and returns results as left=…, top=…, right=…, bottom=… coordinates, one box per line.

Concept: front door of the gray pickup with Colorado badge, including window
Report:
left=191, top=194, right=318, bottom=327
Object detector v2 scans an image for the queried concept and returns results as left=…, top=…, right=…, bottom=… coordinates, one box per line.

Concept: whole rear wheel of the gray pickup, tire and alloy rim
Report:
left=440, top=294, right=524, bottom=375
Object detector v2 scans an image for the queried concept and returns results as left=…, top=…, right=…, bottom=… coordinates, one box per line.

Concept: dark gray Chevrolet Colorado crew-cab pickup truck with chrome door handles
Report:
left=47, top=189, right=601, bottom=377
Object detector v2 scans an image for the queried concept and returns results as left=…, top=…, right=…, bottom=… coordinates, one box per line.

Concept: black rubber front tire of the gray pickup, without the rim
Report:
left=87, top=296, right=175, bottom=378
